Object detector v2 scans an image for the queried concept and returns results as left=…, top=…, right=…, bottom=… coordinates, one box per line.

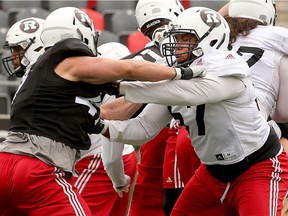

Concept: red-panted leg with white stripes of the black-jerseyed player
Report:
left=1, top=154, right=92, bottom=216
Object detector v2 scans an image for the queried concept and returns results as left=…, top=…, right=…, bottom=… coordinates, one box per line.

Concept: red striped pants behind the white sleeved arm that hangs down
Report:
left=73, top=151, right=137, bottom=216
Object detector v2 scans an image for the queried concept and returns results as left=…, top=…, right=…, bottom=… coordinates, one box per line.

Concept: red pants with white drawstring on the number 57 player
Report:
left=171, top=152, right=288, bottom=216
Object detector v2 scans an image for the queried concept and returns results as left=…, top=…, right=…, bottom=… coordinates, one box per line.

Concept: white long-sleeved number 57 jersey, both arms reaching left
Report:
left=109, top=49, right=270, bottom=165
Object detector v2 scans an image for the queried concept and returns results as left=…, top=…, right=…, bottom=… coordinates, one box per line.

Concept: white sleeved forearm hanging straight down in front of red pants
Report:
left=101, top=135, right=127, bottom=187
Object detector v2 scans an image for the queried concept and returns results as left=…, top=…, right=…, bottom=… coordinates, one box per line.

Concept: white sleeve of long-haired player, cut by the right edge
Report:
left=271, top=56, right=288, bottom=123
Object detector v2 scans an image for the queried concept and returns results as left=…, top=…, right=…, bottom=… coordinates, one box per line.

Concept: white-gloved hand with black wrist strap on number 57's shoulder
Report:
left=172, top=65, right=207, bottom=80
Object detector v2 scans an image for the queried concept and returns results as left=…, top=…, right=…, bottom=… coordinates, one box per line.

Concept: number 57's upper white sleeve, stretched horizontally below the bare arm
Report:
left=121, top=74, right=246, bottom=106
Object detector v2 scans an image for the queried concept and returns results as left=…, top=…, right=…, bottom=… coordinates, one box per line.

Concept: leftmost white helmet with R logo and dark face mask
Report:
left=2, top=17, right=44, bottom=77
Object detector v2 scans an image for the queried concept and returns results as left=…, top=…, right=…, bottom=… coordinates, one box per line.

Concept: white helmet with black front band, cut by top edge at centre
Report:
left=135, top=0, right=184, bottom=39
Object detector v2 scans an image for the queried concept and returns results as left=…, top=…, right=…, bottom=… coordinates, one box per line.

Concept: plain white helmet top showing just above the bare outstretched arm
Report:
left=97, top=42, right=131, bottom=59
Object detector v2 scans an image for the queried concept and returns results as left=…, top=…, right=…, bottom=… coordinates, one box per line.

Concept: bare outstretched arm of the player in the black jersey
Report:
left=54, top=56, right=193, bottom=84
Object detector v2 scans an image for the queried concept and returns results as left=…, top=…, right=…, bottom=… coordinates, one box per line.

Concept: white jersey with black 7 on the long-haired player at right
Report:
left=232, top=25, right=288, bottom=122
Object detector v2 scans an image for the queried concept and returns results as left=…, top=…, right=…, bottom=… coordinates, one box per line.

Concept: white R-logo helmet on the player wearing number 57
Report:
left=162, top=7, right=230, bottom=66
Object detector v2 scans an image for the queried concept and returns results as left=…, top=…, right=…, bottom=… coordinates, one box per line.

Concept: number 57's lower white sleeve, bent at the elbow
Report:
left=107, top=104, right=172, bottom=144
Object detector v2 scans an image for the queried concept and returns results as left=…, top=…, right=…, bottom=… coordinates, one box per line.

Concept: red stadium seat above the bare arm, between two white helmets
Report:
left=127, top=31, right=149, bottom=53
